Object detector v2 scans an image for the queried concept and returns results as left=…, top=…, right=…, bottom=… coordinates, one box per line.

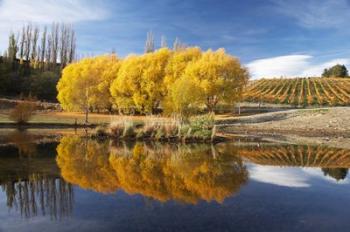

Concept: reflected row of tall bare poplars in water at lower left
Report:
left=1, top=174, right=74, bottom=219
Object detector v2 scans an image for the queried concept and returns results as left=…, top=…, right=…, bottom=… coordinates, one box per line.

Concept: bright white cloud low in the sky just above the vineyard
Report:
left=247, top=55, right=350, bottom=79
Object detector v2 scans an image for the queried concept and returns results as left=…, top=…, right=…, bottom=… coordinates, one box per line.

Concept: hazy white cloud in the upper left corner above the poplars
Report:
left=0, top=0, right=108, bottom=51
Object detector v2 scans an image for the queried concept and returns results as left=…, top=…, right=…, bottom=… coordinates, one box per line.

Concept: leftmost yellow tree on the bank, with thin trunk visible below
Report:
left=57, top=55, right=120, bottom=123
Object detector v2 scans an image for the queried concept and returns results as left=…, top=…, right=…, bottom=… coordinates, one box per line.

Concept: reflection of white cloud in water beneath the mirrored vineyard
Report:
left=249, top=165, right=310, bottom=188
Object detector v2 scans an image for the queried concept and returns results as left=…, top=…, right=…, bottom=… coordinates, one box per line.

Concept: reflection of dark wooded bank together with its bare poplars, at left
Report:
left=0, top=144, right=73, bottom=219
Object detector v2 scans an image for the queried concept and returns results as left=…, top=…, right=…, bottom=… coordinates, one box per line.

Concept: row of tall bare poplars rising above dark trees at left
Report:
left=4, top=23, right=76, bottom=70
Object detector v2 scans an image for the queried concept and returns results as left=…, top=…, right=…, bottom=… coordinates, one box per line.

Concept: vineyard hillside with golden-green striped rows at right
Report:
left=244, top=78, right=350, bottom=107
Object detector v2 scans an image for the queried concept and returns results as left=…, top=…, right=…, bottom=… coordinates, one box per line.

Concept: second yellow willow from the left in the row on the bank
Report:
left=110, top=48, right=172, bottom=113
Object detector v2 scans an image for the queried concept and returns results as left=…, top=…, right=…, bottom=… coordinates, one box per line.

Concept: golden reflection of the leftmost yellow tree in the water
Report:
left=56, top=136, right=119, bottom=193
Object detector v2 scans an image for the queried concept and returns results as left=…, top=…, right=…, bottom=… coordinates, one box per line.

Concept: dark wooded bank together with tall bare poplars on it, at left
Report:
left=0, top=23, right=76, bottom=101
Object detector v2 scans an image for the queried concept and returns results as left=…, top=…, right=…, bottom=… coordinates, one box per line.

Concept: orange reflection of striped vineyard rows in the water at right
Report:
left=239, top=144, right=350, bottom=168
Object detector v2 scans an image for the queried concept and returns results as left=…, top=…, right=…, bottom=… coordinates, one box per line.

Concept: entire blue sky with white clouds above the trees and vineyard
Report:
left=0, top=0, right=350, bottom=78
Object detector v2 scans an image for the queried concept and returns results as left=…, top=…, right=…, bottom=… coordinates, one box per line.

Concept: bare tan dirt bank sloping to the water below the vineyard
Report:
left=217, top=107, right=350, bottom=147
